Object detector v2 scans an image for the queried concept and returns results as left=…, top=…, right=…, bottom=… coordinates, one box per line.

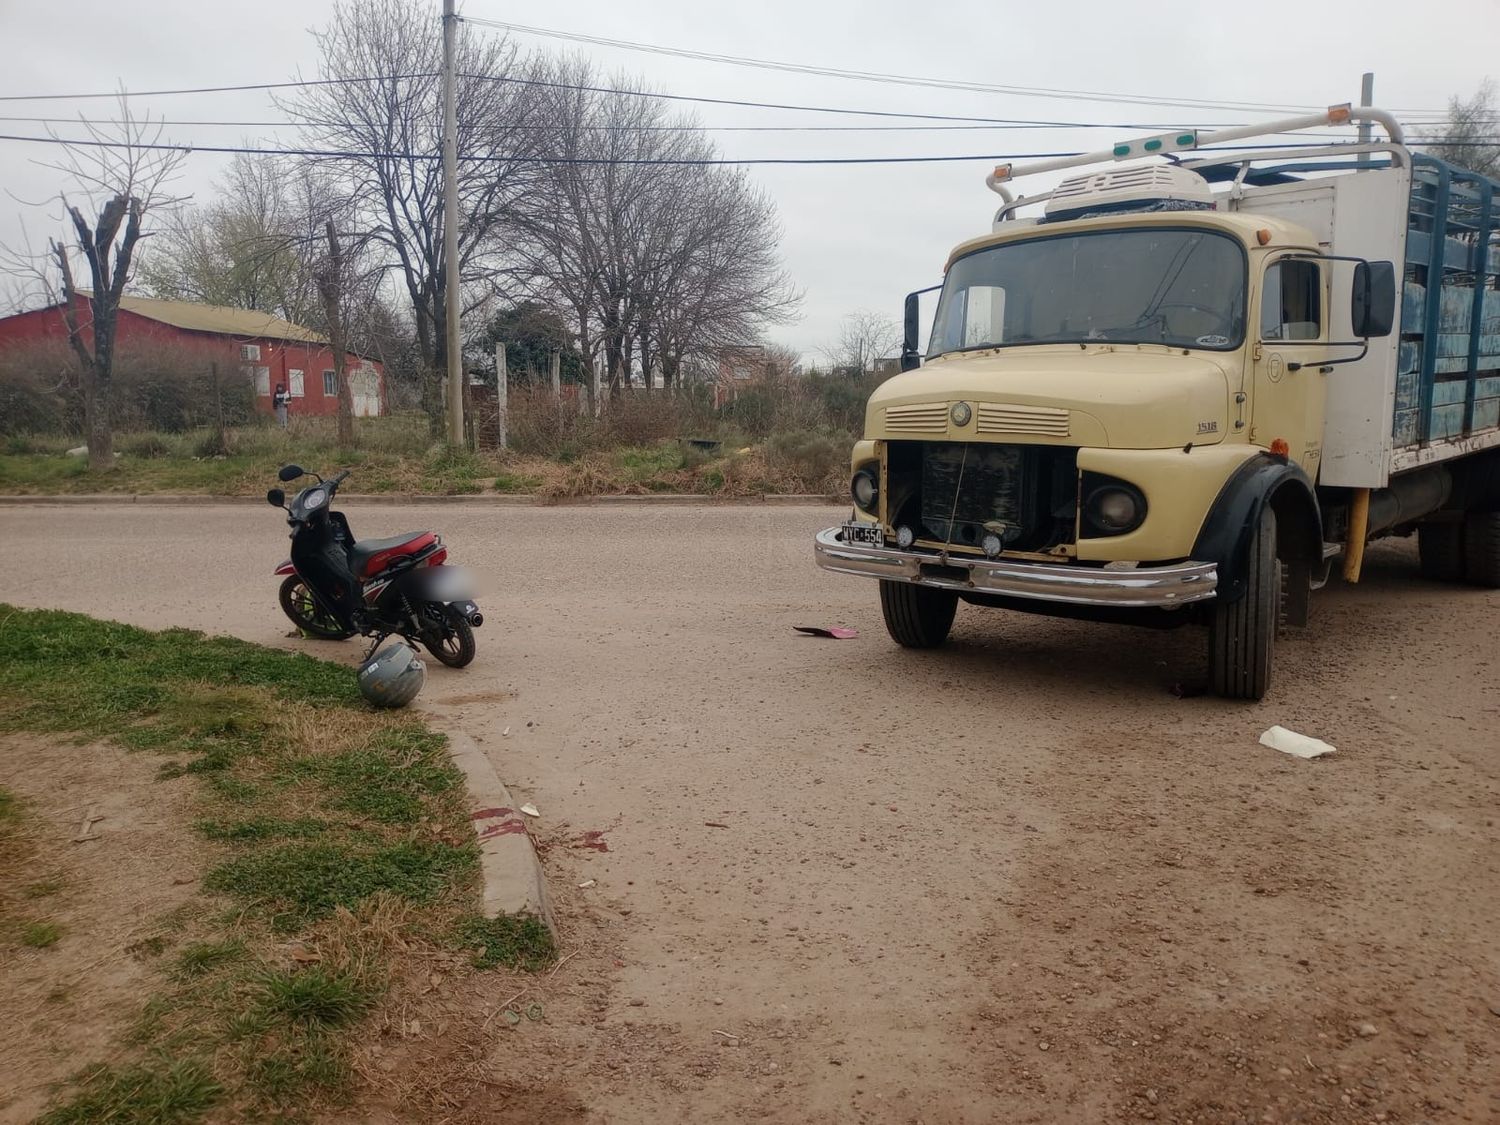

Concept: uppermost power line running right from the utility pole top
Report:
left=461, top=17, right=1452, bottom=119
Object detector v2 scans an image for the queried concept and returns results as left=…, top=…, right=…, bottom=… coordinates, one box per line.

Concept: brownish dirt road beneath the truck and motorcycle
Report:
left=0, top=503, right=1500, bottom=1124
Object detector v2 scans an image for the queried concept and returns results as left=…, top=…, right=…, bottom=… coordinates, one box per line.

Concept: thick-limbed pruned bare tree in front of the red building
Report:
left=11, top=95, right=188, bottom=470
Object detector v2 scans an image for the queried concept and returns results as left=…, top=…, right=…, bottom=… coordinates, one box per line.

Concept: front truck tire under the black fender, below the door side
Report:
left=1209, top=504, right=1283, bottom=699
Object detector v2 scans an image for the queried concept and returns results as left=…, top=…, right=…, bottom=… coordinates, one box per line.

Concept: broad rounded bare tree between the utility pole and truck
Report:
left=519, top=62, right=798, bottom=405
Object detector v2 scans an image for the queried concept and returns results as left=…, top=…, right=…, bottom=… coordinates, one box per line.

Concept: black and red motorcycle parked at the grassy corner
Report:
left=266, top=465, right=485, bottom=668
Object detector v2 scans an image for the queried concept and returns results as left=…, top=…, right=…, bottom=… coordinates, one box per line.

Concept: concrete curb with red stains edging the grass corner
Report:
left=425, top=708, right=558, bottom=941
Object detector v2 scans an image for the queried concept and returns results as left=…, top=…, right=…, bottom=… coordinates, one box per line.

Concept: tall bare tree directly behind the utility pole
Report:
left=281, top=0, right=536, bottom=434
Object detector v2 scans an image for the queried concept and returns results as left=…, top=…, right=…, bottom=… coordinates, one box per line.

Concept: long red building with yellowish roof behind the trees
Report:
left=0, top=297, right=387, bottom=417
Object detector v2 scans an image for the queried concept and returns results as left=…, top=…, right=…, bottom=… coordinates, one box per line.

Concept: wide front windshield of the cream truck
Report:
left=927, top=228, right=1247, bottom=357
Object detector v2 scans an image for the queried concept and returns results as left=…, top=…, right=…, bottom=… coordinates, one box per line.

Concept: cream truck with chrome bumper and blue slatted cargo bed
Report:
left=815, top=105, right=1500, bottom=699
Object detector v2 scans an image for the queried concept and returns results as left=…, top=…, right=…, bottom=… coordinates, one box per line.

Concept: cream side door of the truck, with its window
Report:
left=1250, top=257, right=1329, bottom=480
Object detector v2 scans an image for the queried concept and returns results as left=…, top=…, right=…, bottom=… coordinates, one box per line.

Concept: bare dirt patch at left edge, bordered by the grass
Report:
left=0, top=735, right=198, bottom=1122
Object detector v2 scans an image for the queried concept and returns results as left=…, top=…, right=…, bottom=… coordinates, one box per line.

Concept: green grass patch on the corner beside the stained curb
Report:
left=0, top=605, right=552, bottom=1122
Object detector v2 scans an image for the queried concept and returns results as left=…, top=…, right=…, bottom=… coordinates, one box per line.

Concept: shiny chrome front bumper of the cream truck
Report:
left=813, top=528, right=1218, bottom=609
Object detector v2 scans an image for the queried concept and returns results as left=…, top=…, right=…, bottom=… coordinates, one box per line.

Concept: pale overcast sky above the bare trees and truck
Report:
left=0, top=0, right=1500, bottom=359
